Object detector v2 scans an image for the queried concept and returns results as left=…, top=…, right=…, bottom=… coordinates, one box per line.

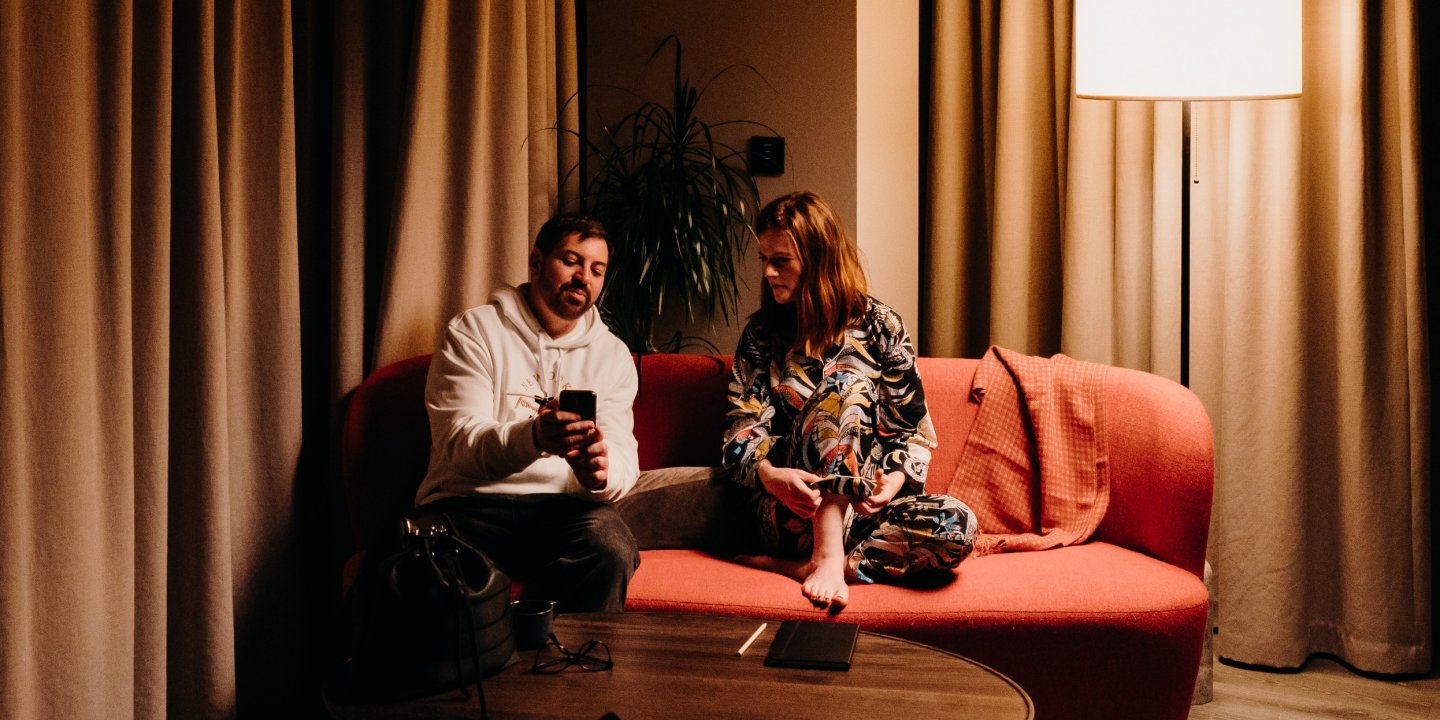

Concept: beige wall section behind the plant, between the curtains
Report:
left=586, top=0, right=919, bottom=353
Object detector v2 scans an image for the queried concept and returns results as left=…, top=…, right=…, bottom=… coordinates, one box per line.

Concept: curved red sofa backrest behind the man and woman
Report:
left=341, top=354, right=1214, bottom=573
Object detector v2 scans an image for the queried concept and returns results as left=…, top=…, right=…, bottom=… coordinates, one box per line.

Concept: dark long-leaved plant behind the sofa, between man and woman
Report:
left=570, top=35, right=773, bottom=353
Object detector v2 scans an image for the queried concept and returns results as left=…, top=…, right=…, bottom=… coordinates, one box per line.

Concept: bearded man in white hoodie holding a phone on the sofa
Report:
left=415, top=215, right=639, bottom=612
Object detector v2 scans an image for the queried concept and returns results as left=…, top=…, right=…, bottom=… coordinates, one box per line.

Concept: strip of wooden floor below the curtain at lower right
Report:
left=1189, top=658, right=1440, bottom=720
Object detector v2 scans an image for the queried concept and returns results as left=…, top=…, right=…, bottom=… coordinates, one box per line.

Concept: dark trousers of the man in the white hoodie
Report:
left=416, top=494, right=639, bottom=612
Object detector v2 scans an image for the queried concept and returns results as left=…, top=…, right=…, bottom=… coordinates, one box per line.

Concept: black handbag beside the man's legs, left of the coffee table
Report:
left=336, top=514, right=518, bottom=717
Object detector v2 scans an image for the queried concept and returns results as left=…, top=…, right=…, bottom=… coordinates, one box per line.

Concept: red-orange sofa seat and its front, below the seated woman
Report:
left=625, top=543, right=1208, bottom=719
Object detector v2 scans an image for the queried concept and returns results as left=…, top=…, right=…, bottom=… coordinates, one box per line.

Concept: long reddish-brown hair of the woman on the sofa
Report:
left=755, top=192, right=870, bottom=357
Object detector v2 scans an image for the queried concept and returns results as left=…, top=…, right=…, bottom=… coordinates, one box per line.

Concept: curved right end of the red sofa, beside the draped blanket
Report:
left=1094, top=367, right=1215, bottom=579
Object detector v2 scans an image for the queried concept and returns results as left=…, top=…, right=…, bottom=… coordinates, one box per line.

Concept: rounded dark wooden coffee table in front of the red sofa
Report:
left=331, top=612, right=1035, bottom=720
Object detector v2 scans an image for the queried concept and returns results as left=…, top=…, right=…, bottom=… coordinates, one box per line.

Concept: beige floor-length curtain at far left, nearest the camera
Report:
left=0, top=1, right=300, bottom=719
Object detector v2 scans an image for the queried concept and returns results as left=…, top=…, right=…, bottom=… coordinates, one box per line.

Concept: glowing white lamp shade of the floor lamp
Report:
left=1074, top=0, right=1300, bottom=99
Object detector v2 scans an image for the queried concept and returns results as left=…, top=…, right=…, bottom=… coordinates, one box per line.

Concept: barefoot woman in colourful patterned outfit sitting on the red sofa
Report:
left=723, top=192, right=976, bottom=612
